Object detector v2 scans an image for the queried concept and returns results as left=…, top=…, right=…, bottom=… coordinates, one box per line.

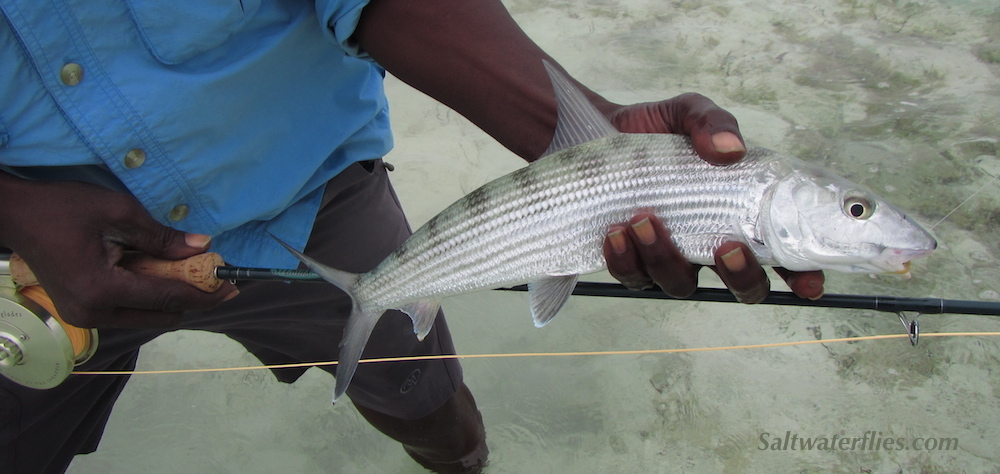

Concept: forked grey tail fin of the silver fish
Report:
left=271, top=235, right=376, bottom=403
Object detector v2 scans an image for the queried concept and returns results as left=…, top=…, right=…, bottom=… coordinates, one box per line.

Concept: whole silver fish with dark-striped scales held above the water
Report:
left=276, top=58, right=936, bottom=400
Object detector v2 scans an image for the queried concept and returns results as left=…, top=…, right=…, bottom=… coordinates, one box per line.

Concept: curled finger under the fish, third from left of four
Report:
left=715, top=242, right=771, bottom=304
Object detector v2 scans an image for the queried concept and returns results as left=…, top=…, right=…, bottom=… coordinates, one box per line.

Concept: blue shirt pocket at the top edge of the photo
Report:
left=125, top=0, right=261, bottom=64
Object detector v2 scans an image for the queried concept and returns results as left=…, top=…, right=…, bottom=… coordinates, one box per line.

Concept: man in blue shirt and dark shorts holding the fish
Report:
left=0, top=0, right=823, bottom=472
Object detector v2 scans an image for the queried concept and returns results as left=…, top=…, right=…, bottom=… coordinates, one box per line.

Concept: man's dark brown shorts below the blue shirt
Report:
left=0, top=161, right=462, bottom=472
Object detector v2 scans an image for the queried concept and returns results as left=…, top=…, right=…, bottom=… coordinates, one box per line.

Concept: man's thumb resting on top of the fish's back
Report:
left=669, top=93, right=746, bottom=165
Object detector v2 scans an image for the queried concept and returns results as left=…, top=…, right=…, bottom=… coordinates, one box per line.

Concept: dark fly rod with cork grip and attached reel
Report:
left=0, top=253, right=1000, bottom=389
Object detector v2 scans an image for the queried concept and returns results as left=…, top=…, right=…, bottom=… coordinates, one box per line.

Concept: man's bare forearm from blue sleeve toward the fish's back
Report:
left=355, top=0, right=617, bottom=160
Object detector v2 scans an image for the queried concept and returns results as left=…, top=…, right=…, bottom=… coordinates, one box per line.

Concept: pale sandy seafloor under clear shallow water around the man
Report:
left=70, top=0, right=1000, bottom=473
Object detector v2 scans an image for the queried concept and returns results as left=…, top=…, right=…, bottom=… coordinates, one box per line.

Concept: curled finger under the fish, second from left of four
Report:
left=628, top=213, right=698, bottom=298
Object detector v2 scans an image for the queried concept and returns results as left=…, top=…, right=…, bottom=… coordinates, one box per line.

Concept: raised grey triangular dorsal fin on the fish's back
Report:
left=542, top=59, right=620, bottom=156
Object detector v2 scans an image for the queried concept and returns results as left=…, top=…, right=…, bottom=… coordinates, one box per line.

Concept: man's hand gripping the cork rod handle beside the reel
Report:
left=0, top=173, right=237, bottom=328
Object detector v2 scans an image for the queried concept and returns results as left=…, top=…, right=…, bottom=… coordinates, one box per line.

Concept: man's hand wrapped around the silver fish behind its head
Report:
left=604, top=94, right=824, bottom=303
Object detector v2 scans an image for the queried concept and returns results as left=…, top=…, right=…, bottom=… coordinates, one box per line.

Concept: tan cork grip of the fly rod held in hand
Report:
left=10, top=252, right=224, bottom=293
